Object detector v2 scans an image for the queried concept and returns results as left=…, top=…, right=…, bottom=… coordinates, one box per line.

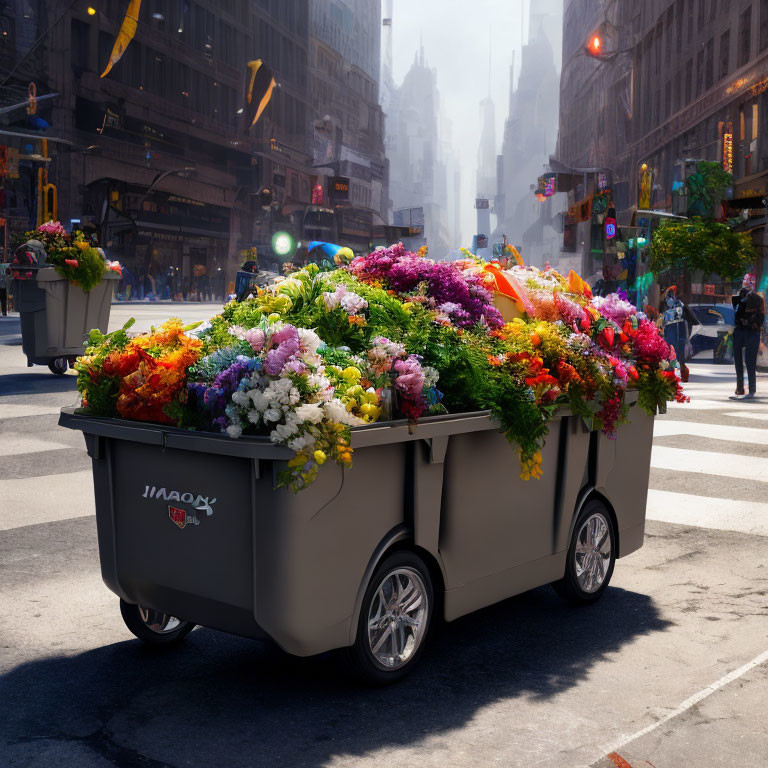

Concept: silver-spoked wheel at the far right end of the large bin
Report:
left=552, top=499, right=616, bottom=605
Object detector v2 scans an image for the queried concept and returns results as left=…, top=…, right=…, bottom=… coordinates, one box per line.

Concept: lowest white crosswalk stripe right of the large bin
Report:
left=646, top=492, right=768, bottom=536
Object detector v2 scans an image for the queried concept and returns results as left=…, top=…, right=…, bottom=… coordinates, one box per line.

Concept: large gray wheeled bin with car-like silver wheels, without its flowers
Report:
left=59, top=393, right=653, bottom=682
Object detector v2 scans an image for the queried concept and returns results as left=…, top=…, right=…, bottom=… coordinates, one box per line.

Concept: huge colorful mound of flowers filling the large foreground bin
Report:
left=72, top=245, right=686, bottom=491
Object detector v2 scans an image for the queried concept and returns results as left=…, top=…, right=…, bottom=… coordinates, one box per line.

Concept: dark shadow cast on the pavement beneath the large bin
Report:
left=0, top=588, right=670, bottom=768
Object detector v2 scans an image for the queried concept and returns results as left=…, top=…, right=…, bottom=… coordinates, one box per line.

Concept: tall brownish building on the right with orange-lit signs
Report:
left=553, top=0, right=768, bottom=290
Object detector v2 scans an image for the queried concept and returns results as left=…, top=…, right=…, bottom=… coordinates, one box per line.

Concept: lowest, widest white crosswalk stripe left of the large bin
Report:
left=0, top=470, right=96, bottom=531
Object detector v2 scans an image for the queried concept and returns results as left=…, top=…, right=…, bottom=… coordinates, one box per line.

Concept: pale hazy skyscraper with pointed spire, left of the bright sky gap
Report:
left=387, top=47, right=452, bottom=259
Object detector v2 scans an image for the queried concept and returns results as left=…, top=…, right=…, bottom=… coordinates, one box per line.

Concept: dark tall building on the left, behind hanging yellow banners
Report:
left=3, top=0, right=311, bottom=298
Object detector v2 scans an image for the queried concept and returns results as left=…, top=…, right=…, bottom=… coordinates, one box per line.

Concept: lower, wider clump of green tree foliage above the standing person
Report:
left=651, top=219, right=757, bottom=280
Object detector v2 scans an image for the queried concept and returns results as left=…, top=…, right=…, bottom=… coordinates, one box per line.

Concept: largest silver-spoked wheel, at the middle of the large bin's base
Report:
left=345, top=552, right=435, bottom=685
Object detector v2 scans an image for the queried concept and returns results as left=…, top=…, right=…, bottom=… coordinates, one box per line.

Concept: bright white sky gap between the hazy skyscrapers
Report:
left=392, top=0, right=540, bottom=247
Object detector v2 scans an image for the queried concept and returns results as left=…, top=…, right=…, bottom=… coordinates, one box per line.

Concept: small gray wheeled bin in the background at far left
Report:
left=13, top=267, right=120, bottom=374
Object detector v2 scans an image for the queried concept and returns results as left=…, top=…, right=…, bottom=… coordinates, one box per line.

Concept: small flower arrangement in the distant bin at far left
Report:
left=17, top=221, right=121, bottom=293
